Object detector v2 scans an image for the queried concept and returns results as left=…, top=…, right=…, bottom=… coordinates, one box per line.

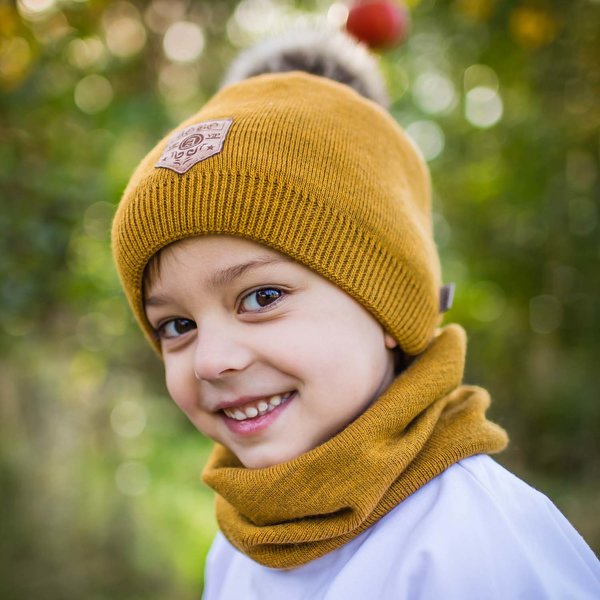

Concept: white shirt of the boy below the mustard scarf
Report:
left=203, top=455, right=600, bottom=600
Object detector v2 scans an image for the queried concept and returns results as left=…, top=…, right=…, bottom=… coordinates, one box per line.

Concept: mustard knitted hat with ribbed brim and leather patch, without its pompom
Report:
left=112, top=72, right=440, bottom=355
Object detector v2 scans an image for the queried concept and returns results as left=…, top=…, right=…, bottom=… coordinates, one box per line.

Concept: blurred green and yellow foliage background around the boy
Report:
left=0, top=0, right=600, bottom=600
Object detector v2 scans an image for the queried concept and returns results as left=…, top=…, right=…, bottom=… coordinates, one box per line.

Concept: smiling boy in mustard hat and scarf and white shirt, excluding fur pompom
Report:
left=113, top=29, right=600, bottom=599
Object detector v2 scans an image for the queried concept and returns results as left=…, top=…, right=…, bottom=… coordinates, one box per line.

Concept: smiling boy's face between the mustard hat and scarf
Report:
left=146, top=236, right=396, bottom=468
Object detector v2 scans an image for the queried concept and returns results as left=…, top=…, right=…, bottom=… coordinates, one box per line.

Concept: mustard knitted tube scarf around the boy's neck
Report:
left=203, top=325, right=508, bottom=568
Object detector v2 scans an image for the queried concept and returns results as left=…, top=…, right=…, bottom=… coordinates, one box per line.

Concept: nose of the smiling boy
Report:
left=193, top=324, right=252, bottom=381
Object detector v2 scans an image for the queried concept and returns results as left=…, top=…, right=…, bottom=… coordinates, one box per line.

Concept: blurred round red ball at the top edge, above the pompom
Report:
left=346, top=0, right=410, bottom=48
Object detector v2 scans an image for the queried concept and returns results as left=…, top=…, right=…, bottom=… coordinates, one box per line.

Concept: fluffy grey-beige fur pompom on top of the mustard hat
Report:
left=223, top=28, right=389, bottom=108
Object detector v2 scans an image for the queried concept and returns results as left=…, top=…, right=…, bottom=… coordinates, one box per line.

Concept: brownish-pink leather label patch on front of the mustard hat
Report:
left=154, top=119, right=233, bottom=175
